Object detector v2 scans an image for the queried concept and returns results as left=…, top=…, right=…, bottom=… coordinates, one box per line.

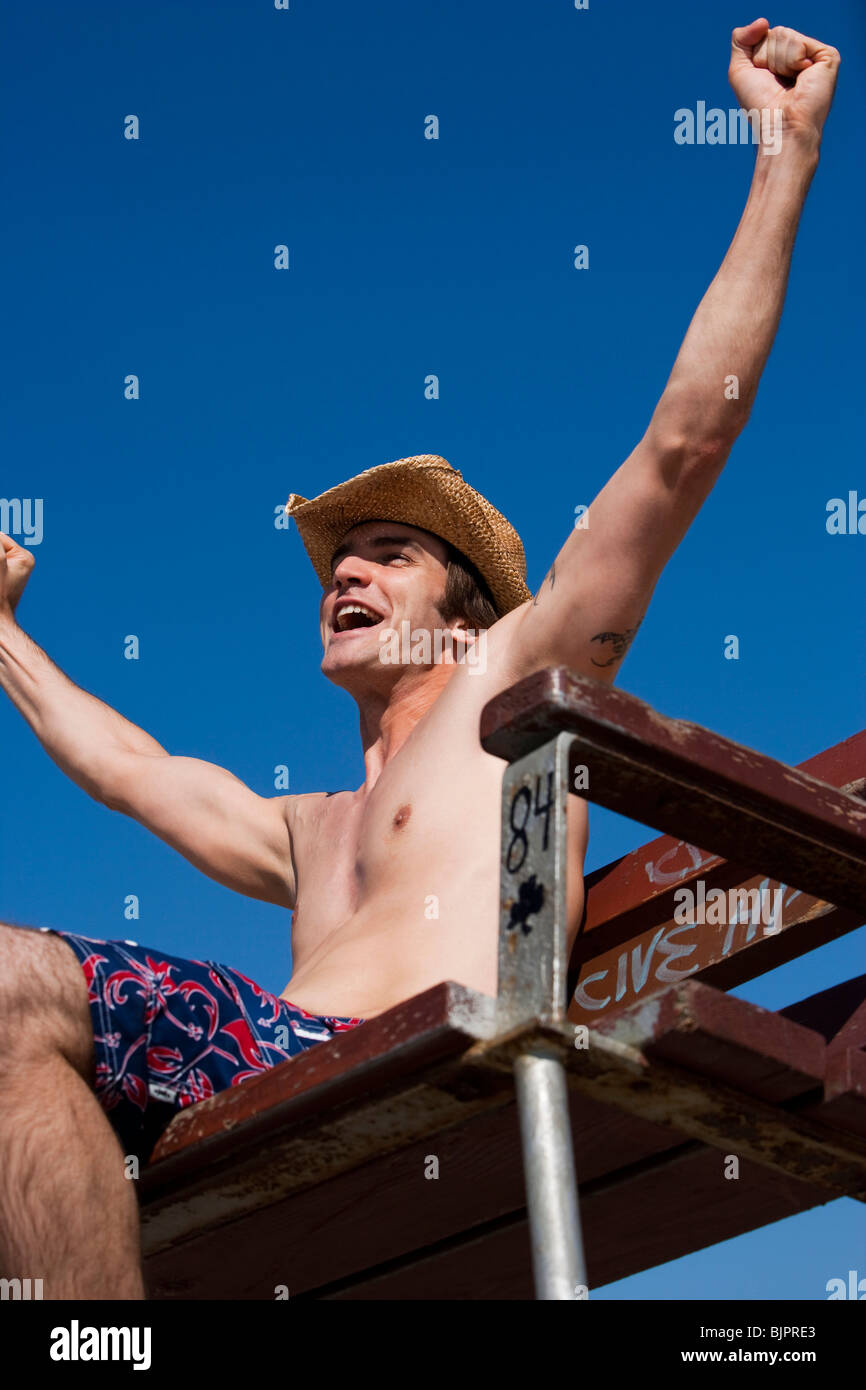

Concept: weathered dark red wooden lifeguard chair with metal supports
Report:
left=139, top=670, right=866, bottom=1300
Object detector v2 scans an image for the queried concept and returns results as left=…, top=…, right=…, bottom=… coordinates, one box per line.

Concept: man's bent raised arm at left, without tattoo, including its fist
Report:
left=0, top=532, right=295, bottom=908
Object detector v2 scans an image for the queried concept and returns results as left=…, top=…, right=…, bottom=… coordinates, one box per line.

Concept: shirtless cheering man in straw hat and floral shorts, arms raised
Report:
left=0, top=19, right=840, bottom=1298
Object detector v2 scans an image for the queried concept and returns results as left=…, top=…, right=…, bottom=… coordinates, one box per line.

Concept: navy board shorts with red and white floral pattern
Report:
left=38, top=927, right=364, bottom=1162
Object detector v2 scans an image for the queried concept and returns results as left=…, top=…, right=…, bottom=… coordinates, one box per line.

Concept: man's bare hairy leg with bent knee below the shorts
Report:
left=0, top=923, right=145, bottom=1298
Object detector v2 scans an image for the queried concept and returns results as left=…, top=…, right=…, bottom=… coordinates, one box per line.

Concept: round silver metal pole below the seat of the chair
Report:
left=514, top=1052, right=588, bottom=1300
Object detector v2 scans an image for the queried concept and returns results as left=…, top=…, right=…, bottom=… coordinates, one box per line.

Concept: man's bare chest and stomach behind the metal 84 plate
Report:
left=282, top=644, right=587, bottom=1019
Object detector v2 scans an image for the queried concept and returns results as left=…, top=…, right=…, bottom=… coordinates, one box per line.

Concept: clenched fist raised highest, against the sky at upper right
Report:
left=728, top=19, right=841, bottom=145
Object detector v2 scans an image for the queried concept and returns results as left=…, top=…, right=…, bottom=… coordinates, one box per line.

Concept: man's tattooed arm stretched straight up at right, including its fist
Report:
left=503, top=19, right=840, bottom=682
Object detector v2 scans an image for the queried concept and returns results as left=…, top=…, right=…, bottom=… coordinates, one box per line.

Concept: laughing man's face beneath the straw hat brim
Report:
left=320, top=521, right=457, bottom=691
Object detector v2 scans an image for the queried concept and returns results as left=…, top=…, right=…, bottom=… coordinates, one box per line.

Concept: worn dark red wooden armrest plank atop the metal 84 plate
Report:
left=481, top=667, right=866, bottom=916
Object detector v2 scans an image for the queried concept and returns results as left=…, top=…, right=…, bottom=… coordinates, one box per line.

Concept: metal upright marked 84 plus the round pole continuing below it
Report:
left=498, top=734, right=587, bottom=1300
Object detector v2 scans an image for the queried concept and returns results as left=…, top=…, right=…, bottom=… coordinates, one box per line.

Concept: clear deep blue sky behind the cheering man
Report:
left=0, top=0, right=866, bottom=1298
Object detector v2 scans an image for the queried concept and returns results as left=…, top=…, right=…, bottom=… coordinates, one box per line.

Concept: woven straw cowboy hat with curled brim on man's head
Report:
left=285, top=453, right=532, bottom=617
